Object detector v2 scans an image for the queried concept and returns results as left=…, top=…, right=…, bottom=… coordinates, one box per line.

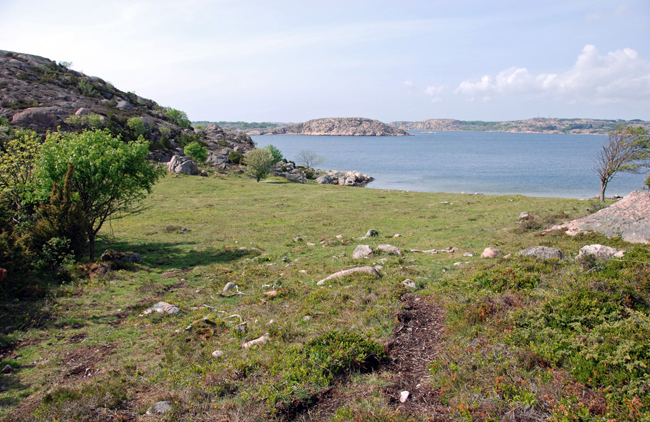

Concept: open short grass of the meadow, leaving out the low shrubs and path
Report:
left=0, top=176, right=636, bottom=420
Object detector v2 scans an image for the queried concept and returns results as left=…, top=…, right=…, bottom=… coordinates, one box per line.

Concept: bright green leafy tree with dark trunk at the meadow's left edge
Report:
left=38, top=130, right=164, bottom=260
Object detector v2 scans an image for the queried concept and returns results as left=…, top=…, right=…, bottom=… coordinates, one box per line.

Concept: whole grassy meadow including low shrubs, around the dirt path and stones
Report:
left=0, top=176, right=650, bottom=421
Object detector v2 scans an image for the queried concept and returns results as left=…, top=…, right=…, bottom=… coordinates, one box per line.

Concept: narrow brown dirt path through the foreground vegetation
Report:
left=385, top=294, right=446, bottom=421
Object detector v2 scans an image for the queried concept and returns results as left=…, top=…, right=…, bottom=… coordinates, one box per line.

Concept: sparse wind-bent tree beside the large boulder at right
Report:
left=593, top=126, right=650, bottom=202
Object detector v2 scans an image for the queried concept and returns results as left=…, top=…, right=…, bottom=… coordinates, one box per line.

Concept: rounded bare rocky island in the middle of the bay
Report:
left=248, top=117, right=411, bottom=136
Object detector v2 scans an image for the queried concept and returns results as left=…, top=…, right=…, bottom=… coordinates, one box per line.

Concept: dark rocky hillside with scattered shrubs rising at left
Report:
left=0, top=50, right=253, bottom=168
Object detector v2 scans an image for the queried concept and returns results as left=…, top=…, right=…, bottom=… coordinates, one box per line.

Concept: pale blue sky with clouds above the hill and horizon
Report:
left=0, top=0, right=650, bottom=122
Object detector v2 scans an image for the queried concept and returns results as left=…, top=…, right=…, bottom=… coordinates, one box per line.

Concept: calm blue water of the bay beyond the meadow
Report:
left=253, top=132, right=646, bottom=198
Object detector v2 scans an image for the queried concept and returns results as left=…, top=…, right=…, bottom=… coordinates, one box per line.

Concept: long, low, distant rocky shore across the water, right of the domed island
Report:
left=390, top=118, right=650, bottom=135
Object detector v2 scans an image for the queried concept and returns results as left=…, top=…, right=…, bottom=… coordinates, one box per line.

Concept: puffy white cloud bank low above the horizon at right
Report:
left=455, top=45, right=650, bottom=104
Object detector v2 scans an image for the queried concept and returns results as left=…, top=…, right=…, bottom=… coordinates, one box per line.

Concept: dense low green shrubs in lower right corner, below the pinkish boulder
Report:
left=511, top=247, right=650, bottom=416
